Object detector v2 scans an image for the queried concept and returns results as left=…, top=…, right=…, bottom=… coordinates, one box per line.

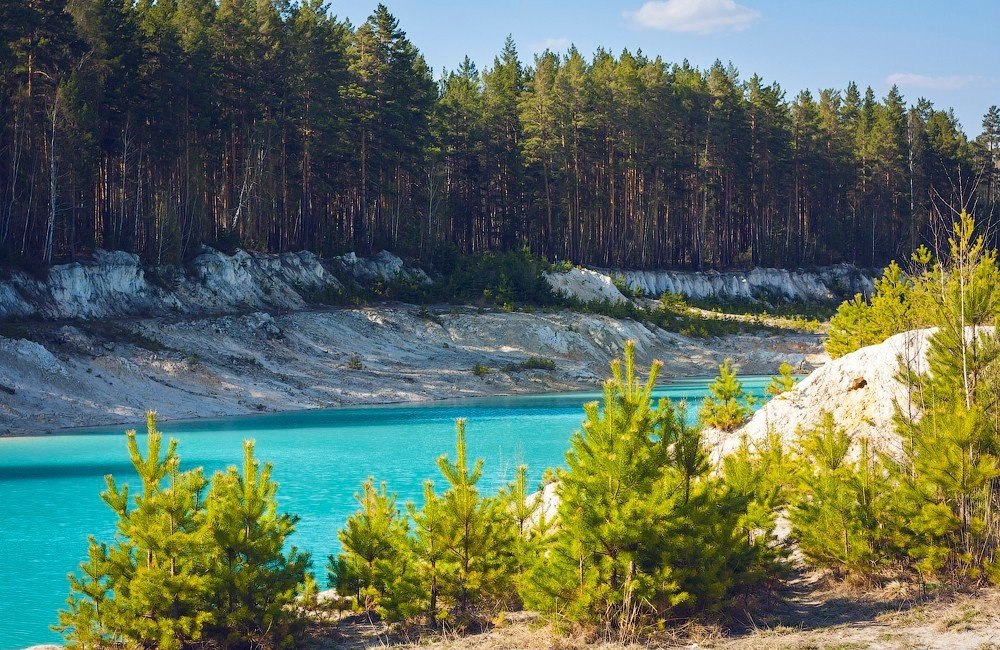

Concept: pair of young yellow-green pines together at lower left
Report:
left=57, top=412, right=309, bottom=650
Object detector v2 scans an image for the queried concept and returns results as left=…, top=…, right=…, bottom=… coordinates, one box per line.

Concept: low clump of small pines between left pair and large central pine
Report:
left=329, top=420, right=538, bottom=628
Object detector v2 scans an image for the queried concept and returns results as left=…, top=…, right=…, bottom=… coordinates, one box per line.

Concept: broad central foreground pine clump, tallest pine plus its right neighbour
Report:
left=525, top=342, right=770, bottom=638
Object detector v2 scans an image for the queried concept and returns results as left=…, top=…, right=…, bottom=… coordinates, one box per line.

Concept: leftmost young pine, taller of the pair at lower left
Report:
left=59, top=412, right=211, bottom=650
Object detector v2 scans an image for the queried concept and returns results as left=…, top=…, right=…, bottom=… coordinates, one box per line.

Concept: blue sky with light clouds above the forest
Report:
left=331, top=0, right=1000, bottom=136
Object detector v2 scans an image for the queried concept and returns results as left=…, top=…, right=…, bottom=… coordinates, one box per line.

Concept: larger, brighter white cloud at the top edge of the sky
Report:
left=625, top=0, right=760, bottom=34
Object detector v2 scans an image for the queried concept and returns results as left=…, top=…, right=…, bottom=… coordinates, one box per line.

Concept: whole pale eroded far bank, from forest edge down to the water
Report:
left=0, top=249, right=852, bottom=434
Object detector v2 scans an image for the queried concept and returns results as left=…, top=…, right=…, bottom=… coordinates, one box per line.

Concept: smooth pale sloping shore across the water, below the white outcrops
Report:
left=0, top=303, right=826, bottom=437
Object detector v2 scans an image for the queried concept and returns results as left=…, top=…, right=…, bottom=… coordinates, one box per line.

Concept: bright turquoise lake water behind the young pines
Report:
left=0, top=377, right=767, bottom=650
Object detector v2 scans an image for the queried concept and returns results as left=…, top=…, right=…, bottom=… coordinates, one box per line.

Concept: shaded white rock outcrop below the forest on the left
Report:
left=0, top=248, right=430, bottom=320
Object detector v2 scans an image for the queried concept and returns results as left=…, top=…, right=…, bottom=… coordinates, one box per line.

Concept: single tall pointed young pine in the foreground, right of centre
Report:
left=528, top=342, right=687, bottom=633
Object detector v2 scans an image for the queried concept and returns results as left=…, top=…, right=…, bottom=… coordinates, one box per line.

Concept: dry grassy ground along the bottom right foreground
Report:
left=307, top=578, right=1000, bottom=650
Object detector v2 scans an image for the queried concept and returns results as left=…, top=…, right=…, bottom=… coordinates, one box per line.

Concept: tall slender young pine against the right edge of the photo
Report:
left=897, top=212, right=1000, bottom=585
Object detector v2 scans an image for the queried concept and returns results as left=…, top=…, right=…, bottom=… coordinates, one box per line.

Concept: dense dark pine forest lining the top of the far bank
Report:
left=0, top=0, right=1000, bottom=268
